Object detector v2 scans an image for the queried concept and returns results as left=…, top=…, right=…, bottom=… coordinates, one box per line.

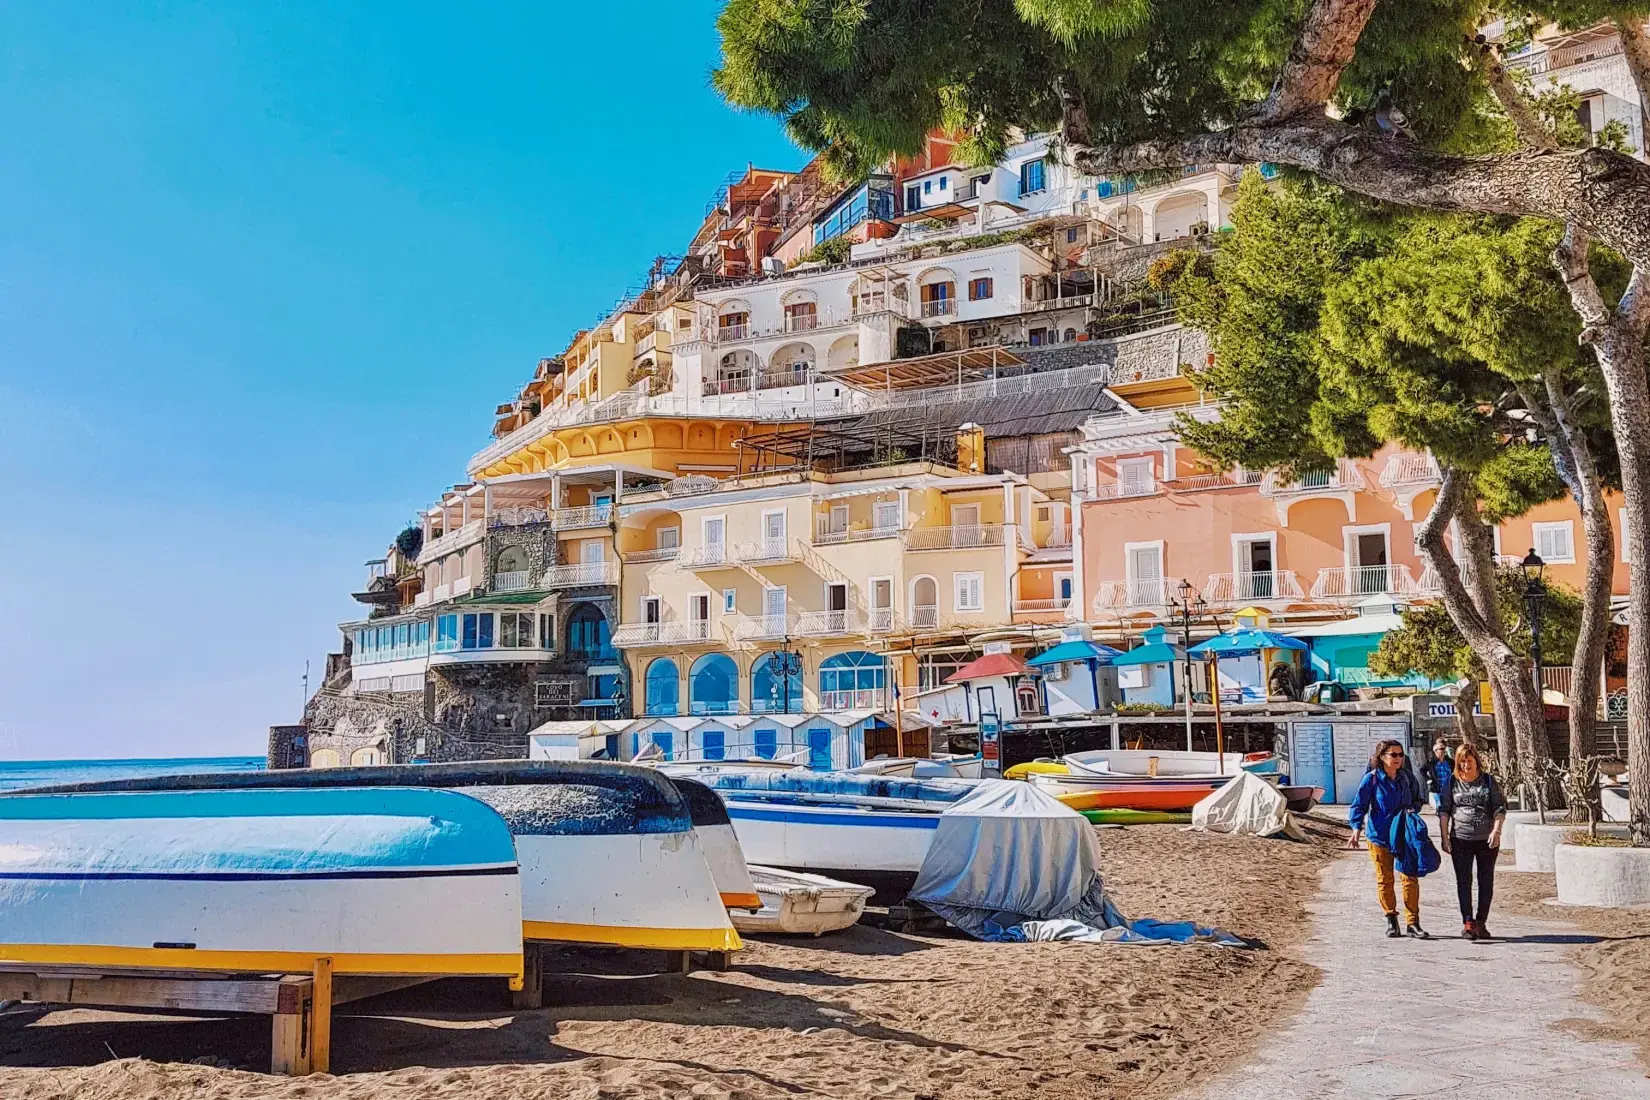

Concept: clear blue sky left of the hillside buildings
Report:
left=0, top=0, right=804, bottom=759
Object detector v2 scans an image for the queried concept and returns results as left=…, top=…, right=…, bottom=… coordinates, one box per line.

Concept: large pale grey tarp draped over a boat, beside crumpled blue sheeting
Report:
left=911, top=780, right=1099, bottom=933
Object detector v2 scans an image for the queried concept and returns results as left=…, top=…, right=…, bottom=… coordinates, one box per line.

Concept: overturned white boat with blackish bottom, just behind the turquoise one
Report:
left=37, top=760, right=754, bottom=952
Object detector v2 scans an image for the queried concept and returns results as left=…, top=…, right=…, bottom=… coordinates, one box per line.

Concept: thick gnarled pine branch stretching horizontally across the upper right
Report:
left=1074, top=114, right=1650, bottom=266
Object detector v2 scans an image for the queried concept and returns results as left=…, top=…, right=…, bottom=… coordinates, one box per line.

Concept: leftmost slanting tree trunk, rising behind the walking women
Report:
left=1416, top=468, right=1551, bottom=794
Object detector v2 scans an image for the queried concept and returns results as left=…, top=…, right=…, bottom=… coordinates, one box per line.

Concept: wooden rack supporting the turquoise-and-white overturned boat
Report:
left=0, top=958, right=441, bottom=1077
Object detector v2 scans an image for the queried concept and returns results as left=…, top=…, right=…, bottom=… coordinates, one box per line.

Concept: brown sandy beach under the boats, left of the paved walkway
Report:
left=0, top=826, right=1333, bottom=1100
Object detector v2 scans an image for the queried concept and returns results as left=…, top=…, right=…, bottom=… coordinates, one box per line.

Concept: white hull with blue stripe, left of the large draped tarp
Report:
left=723, top=792, right=944, bottom=874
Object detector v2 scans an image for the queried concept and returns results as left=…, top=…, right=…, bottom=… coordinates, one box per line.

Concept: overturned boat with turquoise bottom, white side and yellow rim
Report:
left=0, top=788, right=521, bottom=983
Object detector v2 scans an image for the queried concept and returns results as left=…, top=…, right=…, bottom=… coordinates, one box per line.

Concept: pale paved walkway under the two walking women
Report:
left=1198, top=851, right=1650, bottom=1100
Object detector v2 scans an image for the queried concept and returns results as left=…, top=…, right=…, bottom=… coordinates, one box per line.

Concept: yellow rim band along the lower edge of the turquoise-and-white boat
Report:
left=0, top=943, right=521, bottom=981
